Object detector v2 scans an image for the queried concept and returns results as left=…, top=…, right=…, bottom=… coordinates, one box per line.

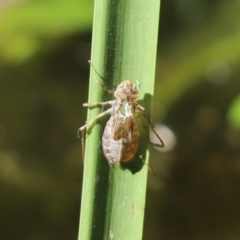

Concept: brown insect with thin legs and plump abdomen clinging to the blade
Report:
left=79, top=61, right=164, bottom=165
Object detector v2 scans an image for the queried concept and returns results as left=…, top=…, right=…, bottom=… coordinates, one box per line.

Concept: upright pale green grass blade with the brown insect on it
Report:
left=79, top=0, right=160, bottom=240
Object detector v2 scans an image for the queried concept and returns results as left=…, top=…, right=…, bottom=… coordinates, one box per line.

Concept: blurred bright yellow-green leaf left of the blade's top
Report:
left=0, top=0, right=93, bottom=62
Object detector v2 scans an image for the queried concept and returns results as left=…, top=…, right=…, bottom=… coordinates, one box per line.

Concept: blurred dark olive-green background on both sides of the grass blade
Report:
left=0, top=0, right=240, bottom=240
